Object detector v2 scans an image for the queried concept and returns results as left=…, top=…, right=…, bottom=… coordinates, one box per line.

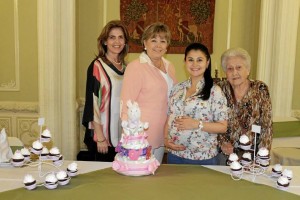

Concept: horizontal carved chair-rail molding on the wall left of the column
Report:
left=0, top=101, right=39, bottom=113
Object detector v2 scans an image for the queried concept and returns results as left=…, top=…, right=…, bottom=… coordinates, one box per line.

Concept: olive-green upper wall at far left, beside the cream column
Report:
left=0, top=0, right=38, bottom=102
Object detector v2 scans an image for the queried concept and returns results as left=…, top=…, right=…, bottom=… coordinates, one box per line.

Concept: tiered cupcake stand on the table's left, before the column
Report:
left=11, top=118, right=78, bottom=190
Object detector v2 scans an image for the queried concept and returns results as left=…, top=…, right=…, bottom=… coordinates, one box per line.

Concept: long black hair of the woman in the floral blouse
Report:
left=184, top=43, right=214, bottom=100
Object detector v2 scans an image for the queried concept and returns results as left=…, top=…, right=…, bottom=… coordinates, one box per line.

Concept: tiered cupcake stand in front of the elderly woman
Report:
left=229, top=125, right=292, bottom=190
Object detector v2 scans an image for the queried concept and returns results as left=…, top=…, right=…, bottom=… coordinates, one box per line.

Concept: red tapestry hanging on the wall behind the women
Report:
left=120, top=0, right=215, bottom=54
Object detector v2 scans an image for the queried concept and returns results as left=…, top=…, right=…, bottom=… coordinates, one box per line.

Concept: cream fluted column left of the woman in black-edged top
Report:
left=37, top=0, right=78, bottom=159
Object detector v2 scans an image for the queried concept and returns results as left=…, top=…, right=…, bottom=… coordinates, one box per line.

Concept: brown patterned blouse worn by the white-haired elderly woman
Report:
left=218, top=80, right=273, bottom=150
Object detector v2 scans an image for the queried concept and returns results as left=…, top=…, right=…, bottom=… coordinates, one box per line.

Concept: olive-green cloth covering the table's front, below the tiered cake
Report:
left=0, top=165, right=300, bottom=200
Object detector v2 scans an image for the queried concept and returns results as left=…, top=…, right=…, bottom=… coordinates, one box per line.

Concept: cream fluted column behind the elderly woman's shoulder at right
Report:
left=257, top=0, right=300, bottom=120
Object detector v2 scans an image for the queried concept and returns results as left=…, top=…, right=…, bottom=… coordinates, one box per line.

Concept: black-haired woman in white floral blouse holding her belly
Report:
left=164, top=43, right=227, bottom=165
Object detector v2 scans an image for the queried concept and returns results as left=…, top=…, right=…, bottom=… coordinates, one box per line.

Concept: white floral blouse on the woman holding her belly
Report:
left=168, top=79, right=227, bottom=160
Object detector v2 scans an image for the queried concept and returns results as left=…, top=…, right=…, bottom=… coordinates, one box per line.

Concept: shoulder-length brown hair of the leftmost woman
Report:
left=97, top=20, right=129, bottom=62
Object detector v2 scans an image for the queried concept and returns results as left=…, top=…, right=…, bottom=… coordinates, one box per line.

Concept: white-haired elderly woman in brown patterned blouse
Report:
left=218, top=48, right=273, bottom=165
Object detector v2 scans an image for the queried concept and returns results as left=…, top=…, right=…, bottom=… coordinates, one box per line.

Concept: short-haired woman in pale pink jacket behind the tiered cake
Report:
left=121, top=23, right=177, bottom=162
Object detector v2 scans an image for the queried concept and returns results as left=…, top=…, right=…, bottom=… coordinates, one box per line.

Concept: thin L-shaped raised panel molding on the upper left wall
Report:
left=0, top=0, right=20, bottom=91
